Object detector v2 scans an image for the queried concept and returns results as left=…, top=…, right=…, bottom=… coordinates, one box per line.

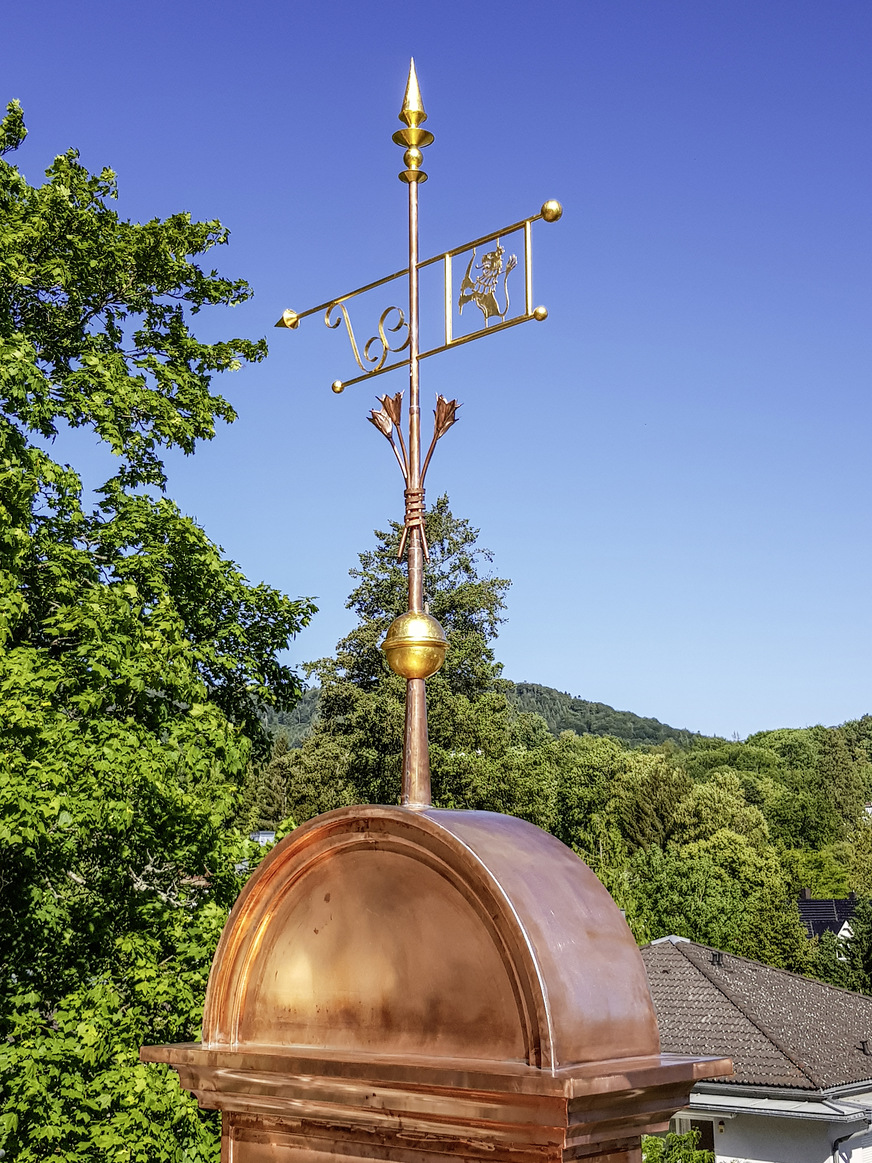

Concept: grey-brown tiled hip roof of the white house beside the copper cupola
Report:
left=642, top=936, right=872, bottom=1091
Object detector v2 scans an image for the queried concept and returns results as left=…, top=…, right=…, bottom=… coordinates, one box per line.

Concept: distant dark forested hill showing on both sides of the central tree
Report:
left=266, top=683, right=699, bottom=747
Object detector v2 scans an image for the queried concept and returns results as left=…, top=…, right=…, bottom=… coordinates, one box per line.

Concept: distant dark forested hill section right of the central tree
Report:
left=507, top=683, right=698, bottom=747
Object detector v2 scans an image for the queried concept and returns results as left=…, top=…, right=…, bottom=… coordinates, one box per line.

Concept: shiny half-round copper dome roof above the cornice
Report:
left=203, top=806, right=659, bottom=1070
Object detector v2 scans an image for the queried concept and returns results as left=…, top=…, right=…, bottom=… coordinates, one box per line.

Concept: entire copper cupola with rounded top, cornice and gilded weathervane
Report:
left=141, top=64, right=730, bottom=1163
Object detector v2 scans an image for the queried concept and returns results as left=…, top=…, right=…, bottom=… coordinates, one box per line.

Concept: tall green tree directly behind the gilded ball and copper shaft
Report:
left=280, top=497, right=556, bottom=828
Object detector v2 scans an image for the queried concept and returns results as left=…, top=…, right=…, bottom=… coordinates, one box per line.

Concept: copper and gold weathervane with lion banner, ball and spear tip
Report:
left=276, top=60, right=563, bottom=807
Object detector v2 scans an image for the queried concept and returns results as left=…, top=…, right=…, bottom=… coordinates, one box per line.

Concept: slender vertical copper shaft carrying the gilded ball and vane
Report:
left=402, top=181, right=430, bottom=807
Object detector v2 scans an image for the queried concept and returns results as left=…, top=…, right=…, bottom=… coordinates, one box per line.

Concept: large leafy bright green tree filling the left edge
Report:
left=0, top=104, right=312, bottom=1163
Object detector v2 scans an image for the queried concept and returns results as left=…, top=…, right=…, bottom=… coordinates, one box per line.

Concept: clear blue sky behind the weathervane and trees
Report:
left=2, top=0, right=872, bottom=736
